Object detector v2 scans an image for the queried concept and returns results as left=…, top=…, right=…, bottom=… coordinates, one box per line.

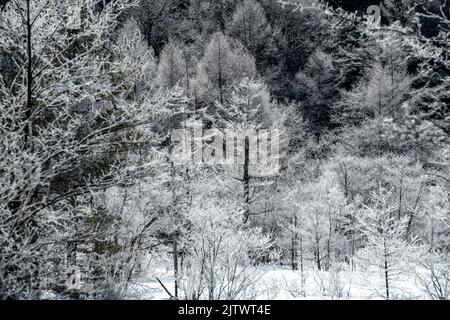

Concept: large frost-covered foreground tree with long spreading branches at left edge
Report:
left=0, top=0, right=169, bottom=297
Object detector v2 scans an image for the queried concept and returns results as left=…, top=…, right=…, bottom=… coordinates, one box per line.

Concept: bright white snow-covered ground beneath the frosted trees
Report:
left=125, top=258, right=427, bottom=300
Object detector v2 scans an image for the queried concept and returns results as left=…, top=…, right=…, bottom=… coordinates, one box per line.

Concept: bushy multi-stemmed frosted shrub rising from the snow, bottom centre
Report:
left=180, top=203, right=271, bottom=300
